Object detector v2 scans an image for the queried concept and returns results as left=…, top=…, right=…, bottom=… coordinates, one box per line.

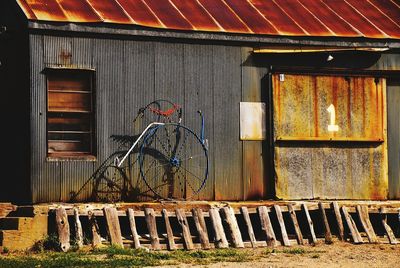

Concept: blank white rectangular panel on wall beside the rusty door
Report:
left=240, top=102, right=266, bottom=141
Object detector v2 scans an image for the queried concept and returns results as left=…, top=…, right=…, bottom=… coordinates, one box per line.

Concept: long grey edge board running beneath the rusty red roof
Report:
left=28, top=21, right=400, bottom=49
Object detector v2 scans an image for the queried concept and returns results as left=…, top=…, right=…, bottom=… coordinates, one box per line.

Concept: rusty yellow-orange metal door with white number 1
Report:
left=272, top=74, right=388, bottom=199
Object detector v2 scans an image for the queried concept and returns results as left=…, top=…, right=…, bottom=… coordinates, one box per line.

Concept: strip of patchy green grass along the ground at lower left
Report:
left=0, top=246, right=255, bottom=268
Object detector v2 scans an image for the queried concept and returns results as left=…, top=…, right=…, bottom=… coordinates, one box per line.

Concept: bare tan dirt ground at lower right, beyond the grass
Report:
left=159, top=241, right=400, bottom=268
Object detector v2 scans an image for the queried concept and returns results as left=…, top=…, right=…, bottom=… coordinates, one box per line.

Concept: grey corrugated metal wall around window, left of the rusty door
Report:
left=30, top=35, right=267, bottom=203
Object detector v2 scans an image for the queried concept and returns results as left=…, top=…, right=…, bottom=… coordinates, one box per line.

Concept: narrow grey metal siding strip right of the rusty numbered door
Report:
left=387, top=80, right=400, bottom=199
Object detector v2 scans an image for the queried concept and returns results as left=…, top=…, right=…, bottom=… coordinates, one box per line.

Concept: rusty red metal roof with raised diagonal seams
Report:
left=17, top=0, right=400, bottom=39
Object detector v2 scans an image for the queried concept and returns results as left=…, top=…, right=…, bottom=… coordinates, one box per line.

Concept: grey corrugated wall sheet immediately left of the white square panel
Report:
left=212, top=46, right=243, bottom=200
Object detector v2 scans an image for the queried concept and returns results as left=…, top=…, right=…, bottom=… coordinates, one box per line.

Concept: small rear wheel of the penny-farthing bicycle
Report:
left=94, top=165, right=128, bottom=203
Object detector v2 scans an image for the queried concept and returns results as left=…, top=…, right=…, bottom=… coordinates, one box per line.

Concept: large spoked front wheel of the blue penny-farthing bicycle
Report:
left=139, top=123, right=208, bottom=200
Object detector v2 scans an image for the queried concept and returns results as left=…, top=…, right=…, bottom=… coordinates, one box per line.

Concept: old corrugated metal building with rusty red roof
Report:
left=0, top=0, right=400, bottom=203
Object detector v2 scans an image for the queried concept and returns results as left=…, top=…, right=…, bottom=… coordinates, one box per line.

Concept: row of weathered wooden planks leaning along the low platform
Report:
left=55, top=202, right=399, bottom=251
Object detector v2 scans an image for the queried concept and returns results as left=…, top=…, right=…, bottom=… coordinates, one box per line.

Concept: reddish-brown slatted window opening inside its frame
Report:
left=47, top=70, right=94, bottom=157
